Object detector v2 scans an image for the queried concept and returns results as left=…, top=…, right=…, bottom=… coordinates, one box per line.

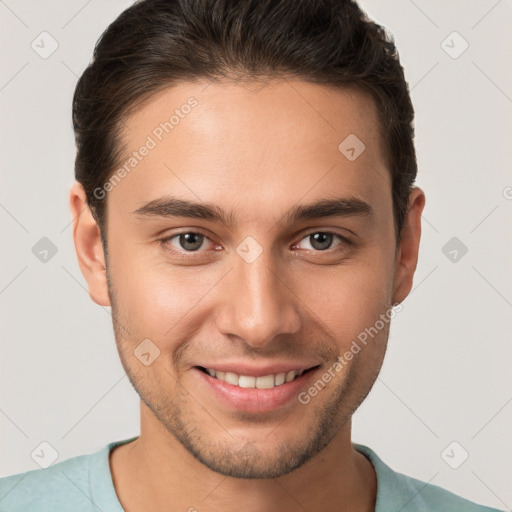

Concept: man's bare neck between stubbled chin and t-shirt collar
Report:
left=110, top=404, right=377, bottom=512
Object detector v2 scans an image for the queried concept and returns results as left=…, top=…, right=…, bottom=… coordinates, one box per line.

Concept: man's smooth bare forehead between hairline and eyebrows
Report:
left=109, top=79, right=391, bottom=224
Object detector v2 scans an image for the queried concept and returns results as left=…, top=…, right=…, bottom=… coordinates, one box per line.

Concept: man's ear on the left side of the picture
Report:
left=69, top=182, right=110, bottom=306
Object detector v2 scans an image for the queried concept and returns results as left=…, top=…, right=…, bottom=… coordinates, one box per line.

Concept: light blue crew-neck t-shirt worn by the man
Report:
left=0, top=436, right=504, bottom=512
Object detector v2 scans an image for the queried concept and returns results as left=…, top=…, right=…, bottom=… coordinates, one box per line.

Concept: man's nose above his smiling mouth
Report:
left=217, top=251, right=301, bottom=348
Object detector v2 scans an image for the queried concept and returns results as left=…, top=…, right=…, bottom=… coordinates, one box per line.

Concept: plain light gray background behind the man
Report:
left=0, top=0, right=512, bottom=510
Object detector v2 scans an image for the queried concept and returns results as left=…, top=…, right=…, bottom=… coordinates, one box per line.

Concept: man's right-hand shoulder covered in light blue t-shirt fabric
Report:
left=354, top=444, right=506, bottom=512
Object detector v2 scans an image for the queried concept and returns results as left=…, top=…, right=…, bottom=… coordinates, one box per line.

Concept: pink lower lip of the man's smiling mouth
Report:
left=192, top=368, right=318, bottom=413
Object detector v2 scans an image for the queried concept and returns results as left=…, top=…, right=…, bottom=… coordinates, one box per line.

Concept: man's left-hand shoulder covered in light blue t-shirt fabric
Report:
left=0, top=441, right=134, bottom=512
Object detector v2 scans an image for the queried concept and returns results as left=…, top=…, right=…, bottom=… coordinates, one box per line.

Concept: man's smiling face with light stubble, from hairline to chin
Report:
left=72, top=80, right=419, bottom=478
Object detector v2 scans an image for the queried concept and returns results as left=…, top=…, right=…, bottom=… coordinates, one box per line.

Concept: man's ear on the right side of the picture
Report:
left=393, top=187, right=425, bottom=304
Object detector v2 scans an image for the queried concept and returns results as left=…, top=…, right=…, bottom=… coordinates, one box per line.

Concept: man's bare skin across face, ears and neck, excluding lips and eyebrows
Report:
left=70, top=79, right=425, bottom=512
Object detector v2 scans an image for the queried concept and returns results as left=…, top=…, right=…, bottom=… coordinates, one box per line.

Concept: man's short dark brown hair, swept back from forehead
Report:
left=73, top=0, right=417, bottom=243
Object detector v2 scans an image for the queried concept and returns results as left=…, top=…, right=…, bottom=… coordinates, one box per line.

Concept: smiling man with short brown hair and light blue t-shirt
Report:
left=0, top=0, right=504, bottom=512
